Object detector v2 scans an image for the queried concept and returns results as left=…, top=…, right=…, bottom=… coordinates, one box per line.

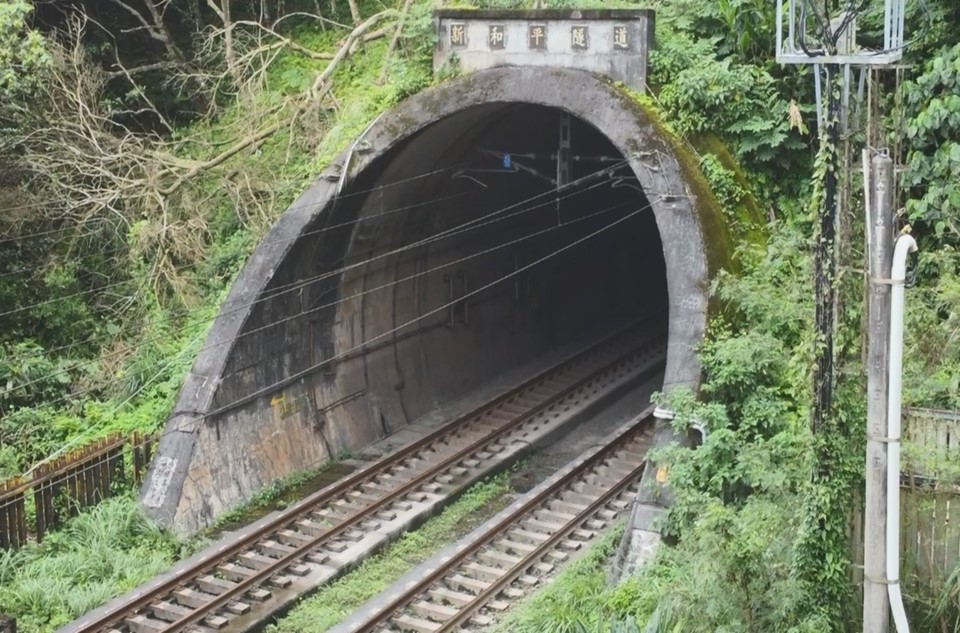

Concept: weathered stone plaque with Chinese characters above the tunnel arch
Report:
left=434, top=9, right=654, bottom=92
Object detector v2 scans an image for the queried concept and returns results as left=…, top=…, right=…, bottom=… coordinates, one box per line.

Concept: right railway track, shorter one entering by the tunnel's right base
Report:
left=340, top=409, right=652, bottom=633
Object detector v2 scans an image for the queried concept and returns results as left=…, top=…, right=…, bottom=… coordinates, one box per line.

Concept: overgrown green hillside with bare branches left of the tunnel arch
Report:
left=0, top=1, right=433, bottom=476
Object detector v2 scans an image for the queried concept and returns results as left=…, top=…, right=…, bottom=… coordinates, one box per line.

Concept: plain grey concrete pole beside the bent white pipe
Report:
left=863, top=150, right=900, bottom=633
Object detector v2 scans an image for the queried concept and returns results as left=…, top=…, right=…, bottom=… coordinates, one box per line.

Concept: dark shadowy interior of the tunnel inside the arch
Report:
left=217, top=103, right=668, bottom=447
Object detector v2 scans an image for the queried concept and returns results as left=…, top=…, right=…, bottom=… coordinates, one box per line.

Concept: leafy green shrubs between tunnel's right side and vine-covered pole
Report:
left=601, top=226, right=859, bottom=633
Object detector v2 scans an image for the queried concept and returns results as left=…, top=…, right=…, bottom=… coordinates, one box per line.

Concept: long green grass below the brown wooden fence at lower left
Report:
left=0, top=496, right=184, bottom=633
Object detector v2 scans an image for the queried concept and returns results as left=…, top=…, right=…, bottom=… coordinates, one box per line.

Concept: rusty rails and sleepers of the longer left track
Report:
left=71, top=323, right=662, bottom=633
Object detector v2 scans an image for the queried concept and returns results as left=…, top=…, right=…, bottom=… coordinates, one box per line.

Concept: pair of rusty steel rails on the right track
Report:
left=355, top=406, right=654, bottom=633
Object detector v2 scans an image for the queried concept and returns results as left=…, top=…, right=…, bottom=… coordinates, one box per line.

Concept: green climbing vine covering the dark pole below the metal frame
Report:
left=793, top=73, right=864, bottom=631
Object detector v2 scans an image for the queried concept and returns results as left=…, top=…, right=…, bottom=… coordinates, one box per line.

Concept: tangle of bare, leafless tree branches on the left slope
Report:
left=0, top=7, right=404, bottom=309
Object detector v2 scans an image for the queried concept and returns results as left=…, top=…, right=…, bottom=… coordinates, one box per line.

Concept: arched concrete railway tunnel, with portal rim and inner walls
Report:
left=141, top=67, right=730, bottom=533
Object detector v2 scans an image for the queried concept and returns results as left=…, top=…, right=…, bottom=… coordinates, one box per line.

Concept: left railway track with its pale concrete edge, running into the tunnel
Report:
left=69, top=324, right=664, bottom=633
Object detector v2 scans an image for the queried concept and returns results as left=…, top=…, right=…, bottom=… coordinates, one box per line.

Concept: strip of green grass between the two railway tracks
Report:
left=267, top=474, right=510, bottom=633
